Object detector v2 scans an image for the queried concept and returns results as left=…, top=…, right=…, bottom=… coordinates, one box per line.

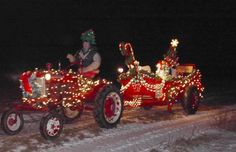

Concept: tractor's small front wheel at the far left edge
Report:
left=1, top=109, right=24, bottom=135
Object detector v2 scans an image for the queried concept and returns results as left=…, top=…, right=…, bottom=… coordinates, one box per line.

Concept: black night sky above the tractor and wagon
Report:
left=0, top=0, right=236, bottom=100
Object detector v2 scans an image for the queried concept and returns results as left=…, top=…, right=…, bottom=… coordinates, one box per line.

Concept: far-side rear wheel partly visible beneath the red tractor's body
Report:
left=63, top=108, right=83, bottom=124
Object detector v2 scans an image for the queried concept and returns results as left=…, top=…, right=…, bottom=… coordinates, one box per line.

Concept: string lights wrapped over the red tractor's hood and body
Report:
left=20, top=70, right=111, bottom=109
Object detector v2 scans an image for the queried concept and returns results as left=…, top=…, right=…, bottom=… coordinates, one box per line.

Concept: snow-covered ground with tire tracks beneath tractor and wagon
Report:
left=0, top=88, right=236, bottom=152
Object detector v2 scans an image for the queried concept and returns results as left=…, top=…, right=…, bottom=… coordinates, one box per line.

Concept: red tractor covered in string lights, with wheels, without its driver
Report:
left=1, top=63, right=123, bottom=139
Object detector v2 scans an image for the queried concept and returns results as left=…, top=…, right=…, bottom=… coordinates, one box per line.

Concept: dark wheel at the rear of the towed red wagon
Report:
left=182, top=87, right=200, bottom=115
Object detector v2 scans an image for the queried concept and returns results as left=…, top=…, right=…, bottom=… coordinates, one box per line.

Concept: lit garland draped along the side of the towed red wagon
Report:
left=121, top=70, right=204, bottom=102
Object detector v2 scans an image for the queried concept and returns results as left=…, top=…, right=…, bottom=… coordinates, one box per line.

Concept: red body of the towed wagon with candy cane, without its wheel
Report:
left=118, top=43, right=204, bottom=111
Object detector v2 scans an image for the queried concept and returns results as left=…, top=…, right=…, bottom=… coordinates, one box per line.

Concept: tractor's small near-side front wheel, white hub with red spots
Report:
left=40, top=112, right=63, bottom=140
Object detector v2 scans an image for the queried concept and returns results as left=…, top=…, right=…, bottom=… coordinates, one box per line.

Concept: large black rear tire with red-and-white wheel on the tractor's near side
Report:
left=93, top=85, right=124, bottom=129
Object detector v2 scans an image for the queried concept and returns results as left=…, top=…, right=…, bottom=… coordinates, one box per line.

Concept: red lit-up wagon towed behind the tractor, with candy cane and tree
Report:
left=118, top=39, right=204, bottom=114
